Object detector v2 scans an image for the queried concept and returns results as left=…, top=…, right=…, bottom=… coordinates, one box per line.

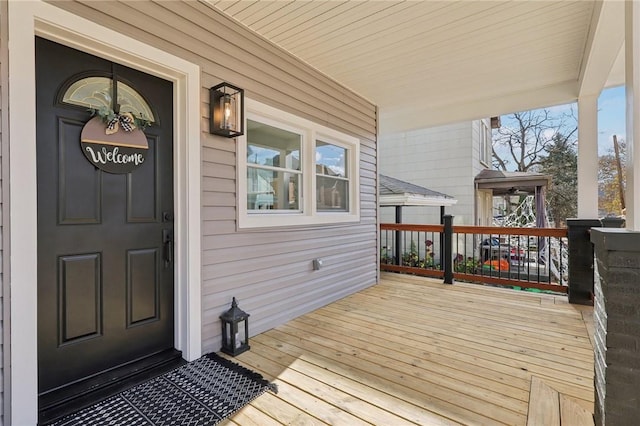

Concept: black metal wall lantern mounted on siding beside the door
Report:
left=209, top=83, right=244, bottom=138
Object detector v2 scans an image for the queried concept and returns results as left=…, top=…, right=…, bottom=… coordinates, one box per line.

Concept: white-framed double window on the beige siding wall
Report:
left=237, top=99, right=360, bottom=228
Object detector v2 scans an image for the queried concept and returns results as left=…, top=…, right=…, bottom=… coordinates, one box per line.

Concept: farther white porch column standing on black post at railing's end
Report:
left=578, top=94, right=598, bottom=219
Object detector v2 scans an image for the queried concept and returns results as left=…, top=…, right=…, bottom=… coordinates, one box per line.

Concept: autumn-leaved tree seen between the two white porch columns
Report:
left=598, top=140, right=627, bottom=216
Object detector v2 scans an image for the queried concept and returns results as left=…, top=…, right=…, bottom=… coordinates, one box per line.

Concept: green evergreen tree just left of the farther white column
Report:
left=540, top=133, right=578, bottom=226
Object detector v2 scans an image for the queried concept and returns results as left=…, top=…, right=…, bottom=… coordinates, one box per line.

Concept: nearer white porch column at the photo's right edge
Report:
left=625, top=1, right=640, bottom=231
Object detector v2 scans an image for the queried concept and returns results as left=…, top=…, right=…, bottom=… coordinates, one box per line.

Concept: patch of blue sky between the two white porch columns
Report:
left=598, top=86, right=626, bottom=155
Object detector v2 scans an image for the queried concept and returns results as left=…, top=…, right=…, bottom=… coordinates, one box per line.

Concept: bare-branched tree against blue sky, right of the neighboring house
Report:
left=492, top=109, right=578, bottom=172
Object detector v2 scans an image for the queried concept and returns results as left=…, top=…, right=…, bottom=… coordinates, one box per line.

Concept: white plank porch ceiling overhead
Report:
left=209, top=0, right=624, bottom=134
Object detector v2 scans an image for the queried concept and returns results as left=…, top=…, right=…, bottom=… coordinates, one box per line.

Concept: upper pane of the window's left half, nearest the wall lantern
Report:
left=247, top=120, right=302, bottom=170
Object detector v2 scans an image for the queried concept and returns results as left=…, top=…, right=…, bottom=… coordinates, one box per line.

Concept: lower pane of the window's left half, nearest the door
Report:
left=247, top=167, right=301, bottom=211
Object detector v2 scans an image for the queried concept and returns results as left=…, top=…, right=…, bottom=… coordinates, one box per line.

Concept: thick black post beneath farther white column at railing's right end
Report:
left=567, top=219, right=602, bottom=305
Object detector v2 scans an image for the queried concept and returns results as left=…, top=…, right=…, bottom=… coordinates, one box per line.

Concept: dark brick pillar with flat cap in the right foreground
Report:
left=591, top=228, right=640, bottom=426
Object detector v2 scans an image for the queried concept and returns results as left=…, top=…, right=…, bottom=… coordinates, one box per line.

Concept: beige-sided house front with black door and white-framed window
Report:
left=0, top=1, right=378, bottom=425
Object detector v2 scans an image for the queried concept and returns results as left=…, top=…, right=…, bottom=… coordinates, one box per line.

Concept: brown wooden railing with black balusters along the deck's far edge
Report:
left=380, top=223, right=568, bottom=293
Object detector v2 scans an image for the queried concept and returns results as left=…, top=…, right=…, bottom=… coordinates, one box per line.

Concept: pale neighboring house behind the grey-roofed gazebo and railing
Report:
left=379, top=119, right=492, bottom=226
